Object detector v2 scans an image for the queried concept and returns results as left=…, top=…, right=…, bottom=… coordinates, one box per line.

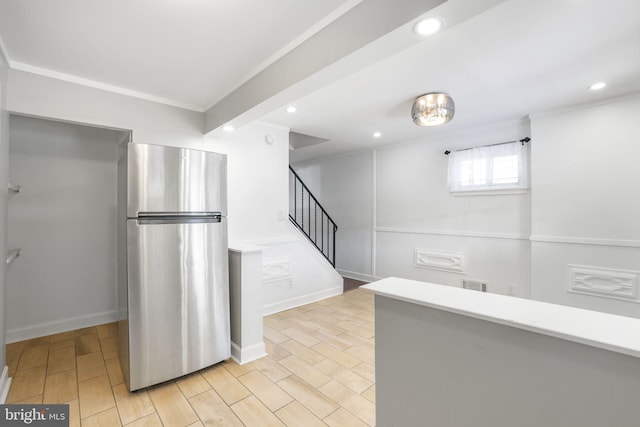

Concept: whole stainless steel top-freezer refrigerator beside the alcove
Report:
left=118, top=143, right=231, bottom=391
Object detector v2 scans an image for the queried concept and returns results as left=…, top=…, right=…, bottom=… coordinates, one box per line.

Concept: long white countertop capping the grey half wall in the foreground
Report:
left=361, top=277, right=640, bottom=357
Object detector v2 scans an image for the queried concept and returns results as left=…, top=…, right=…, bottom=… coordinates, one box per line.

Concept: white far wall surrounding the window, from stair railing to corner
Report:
left=294, top=121, right=531, bottom=296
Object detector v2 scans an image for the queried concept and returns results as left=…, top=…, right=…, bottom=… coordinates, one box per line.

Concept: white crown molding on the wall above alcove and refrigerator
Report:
left=8, top=61, right=204, bottom=113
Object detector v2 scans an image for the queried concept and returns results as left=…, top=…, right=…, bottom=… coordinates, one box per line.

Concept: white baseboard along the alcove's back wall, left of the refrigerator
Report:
left=6, top=310, right=117, bottom=344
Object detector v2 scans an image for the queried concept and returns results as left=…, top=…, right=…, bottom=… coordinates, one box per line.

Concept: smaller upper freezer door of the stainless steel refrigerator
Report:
left=127, top=143, right=227, bottom=218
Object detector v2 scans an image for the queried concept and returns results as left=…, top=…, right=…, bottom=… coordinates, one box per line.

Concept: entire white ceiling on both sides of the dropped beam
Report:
left=0, top=0, right=640, bottom=161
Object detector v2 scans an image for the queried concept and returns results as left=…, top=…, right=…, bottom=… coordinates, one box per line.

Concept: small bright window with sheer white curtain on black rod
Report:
left=449, top=141, right=527, bottom=193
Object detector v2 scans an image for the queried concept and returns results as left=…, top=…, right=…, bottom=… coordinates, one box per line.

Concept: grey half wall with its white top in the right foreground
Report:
left=375, top=288, right=640, bottom=427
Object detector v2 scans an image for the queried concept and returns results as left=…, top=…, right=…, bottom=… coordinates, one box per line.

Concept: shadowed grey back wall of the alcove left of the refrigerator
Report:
left=6, top=116, right=127, bottom=342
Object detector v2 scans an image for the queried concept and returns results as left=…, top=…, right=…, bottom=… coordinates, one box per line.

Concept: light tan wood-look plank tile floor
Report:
left=7, top=289, right=375, bottom=427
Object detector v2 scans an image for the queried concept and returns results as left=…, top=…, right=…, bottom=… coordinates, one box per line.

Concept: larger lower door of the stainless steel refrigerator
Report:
left=127, top=218, right=231, bottom=390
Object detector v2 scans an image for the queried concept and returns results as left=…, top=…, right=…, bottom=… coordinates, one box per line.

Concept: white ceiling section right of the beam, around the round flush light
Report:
left=272, top=0, right=640, bottom=162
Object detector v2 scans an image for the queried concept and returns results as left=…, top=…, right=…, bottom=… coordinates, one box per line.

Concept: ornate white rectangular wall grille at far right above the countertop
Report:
left=567, top=265, right=640, bottom=302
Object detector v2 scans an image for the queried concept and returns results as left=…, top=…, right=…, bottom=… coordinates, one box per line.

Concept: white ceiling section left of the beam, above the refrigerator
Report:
left=0, top=0, right=358, bottom=111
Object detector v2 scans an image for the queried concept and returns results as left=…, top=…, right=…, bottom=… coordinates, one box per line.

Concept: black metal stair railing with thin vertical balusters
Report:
left=289, top=166, right=338, bottom=268
